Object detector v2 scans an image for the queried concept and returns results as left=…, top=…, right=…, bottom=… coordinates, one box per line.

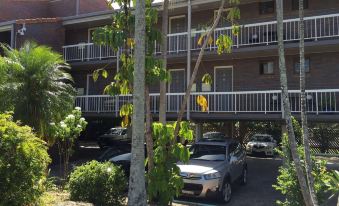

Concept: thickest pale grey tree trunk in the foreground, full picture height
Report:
left=128, top=0, right=146, bottom=203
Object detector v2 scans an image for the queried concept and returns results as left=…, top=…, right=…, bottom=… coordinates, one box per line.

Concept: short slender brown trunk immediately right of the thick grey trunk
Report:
left=145, top=85, right=154, bottom=172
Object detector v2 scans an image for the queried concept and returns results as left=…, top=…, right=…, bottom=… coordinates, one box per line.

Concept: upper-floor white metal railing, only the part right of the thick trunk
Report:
left=161, top=14, right=339, bottom=53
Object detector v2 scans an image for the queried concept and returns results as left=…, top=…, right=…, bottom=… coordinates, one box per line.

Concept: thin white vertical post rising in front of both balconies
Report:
left=186, top=0, right=192, bottom=120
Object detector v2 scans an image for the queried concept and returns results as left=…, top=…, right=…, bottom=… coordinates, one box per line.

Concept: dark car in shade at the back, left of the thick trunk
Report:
left=98, top=127, right=131, bottom=148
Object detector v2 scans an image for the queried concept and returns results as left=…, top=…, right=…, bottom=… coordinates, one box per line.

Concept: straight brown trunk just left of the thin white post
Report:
left=159, top=0, right=168, bottom=124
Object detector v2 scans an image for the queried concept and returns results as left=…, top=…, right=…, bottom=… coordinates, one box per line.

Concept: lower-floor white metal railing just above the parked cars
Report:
left=75, top=89, right=339, bottom=115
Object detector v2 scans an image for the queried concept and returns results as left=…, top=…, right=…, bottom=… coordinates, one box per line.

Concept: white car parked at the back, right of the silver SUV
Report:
left=246, top=134, right=277, bottom=156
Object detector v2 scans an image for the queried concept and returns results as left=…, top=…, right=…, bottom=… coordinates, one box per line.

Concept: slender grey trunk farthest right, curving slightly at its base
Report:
left=299, top=0, right=318, bottom=205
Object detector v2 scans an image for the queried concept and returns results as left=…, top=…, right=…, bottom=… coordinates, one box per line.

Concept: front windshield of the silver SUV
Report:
left=190, top=144, right=226, bottom=161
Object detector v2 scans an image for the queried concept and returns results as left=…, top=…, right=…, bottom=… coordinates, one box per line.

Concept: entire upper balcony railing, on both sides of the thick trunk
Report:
left=63, top=13, right=339, bottom=62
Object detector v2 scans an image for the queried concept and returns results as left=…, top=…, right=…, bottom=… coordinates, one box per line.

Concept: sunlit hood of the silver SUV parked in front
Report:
left=177, top=160, right=224, bottom=174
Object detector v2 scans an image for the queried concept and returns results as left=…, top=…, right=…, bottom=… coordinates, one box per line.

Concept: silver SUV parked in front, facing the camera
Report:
left=177, top=138, right=247, bottom=203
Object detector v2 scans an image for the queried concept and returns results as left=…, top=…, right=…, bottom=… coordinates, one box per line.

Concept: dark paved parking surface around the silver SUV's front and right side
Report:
left=174, top=157, right=283, bottom=206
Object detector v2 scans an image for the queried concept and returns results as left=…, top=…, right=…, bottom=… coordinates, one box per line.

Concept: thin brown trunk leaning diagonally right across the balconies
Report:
left=174, top=0, right=226, bottom=137
